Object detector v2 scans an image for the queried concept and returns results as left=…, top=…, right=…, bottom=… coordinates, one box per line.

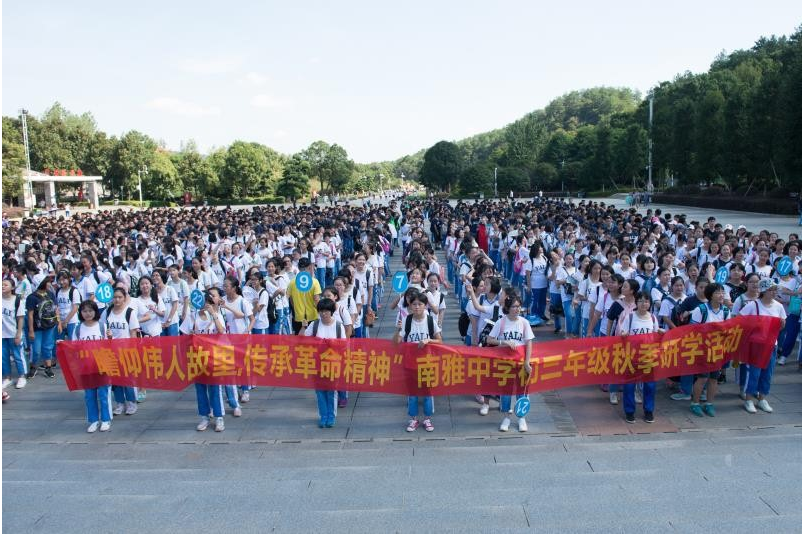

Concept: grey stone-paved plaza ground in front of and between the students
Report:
left=3, top=200, right=801, bottom=532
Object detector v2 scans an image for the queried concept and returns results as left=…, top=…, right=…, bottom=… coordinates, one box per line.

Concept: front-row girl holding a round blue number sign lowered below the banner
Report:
left=488, top=293, right=535, bottom=432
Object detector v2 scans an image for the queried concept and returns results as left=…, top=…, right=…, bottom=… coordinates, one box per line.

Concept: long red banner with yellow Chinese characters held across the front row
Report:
left=57, top=316, right=780, bottom=395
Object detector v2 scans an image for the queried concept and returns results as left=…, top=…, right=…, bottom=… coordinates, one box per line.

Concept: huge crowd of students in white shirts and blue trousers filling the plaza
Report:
left=2, top=197, right=801, bottom=432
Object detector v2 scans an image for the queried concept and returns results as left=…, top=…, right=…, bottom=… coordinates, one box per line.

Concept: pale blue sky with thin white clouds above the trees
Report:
left=2, top=0, right=801, bottom=162
